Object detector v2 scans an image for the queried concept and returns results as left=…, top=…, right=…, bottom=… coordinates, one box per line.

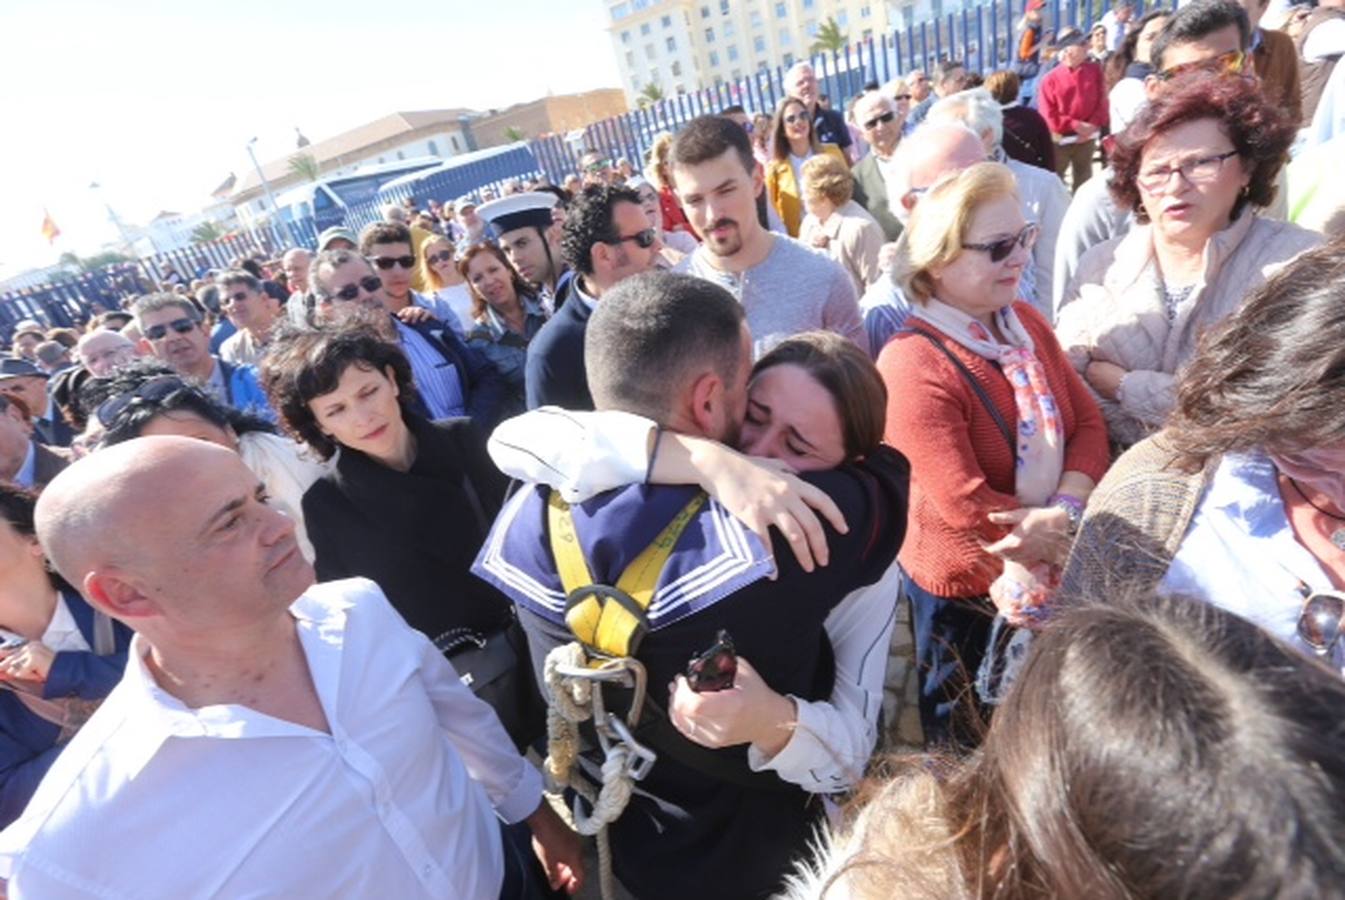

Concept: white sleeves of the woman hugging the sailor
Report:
left=487, top=406, right=901, bottom=794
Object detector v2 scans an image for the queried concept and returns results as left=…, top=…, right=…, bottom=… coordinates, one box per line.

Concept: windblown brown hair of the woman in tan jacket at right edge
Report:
left=1167, top=241, right=1345, bottom=471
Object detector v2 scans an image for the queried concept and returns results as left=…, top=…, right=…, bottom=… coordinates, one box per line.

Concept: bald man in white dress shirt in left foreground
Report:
left=0, top=437, right=582, bottom=900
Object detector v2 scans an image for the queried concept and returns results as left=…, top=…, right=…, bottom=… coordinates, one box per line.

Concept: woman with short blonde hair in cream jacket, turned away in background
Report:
left=799, top=155, right=886, bottom=296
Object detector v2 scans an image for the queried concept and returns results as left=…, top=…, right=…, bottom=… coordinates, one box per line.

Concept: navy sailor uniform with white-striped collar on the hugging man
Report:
left=472, top=452, right=909, bottom=900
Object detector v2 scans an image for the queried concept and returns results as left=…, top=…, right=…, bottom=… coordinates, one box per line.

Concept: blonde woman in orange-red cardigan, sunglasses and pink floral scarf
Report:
left=878, top=163, right=1108, bottom=745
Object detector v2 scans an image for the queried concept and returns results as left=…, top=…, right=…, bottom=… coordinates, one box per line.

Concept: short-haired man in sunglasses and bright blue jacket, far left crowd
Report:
left=132, top=293, right=276, bottom=421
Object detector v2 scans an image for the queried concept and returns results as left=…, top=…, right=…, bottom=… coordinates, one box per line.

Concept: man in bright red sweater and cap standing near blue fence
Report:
left=1037, top=28, right=1110, bottom=191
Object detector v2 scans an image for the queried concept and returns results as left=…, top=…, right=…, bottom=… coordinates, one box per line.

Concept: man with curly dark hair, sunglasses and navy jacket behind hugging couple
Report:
left=526, top=184, right=659, bottom=409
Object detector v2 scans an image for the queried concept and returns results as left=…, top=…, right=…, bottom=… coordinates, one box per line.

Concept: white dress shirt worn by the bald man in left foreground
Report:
left=0, top=578, right=542, bottom=900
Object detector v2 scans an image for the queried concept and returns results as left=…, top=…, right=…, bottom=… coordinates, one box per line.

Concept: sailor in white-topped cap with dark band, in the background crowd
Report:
left=476, top=191, right=573, bottom=315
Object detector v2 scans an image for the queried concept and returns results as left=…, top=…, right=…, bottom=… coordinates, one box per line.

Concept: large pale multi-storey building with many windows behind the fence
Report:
left=604, top=0, right=957, bottom=104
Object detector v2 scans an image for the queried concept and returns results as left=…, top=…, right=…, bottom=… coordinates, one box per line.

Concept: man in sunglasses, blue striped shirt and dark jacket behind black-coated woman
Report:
left=309, top=250, right=504, bottom=429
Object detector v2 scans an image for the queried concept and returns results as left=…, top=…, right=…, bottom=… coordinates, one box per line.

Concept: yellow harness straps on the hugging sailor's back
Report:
left=546, top=491, right=706, bottom=658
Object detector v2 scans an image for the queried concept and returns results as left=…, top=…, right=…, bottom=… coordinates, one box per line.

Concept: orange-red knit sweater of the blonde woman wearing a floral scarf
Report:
left=878, top=303, right=1110, bottom=597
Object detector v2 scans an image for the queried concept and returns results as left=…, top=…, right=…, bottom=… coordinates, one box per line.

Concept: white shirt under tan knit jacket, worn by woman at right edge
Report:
left=1158, top=453, right=1345, bottom=669
